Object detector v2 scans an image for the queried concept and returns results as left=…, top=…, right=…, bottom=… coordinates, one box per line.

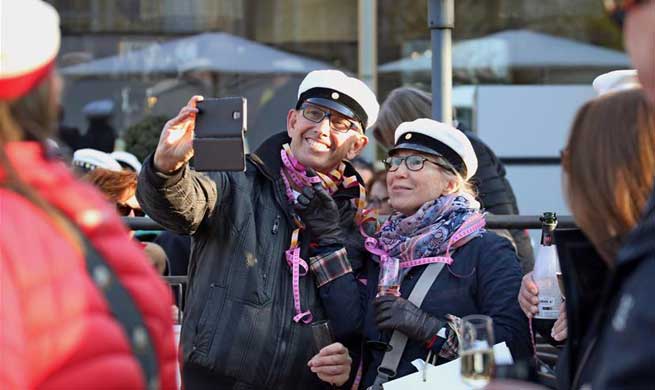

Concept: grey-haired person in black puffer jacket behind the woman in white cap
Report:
left=373, top=87, right=534, bottom=274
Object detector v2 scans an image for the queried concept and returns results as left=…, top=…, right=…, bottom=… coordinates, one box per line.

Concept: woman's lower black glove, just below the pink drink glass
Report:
left=373, top=295, right=445, bottom=341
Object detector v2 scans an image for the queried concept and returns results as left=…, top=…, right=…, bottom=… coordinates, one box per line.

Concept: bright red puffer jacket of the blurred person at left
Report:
left=0, top=142, right=176, bottom=390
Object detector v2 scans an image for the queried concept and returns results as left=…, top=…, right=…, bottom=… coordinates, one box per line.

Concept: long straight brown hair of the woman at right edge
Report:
left=562, top=89, right=655, bottom=262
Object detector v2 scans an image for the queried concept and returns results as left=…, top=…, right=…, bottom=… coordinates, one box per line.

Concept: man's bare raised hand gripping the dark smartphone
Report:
left=153, top=96, right=203, bottom=173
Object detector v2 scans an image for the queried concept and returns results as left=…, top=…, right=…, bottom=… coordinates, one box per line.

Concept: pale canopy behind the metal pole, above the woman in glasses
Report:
left=378, top=30, right=630, bottom=76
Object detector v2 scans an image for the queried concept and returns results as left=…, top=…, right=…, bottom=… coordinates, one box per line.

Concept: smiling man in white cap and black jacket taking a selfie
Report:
left=137, top=70, right=379, bottom=389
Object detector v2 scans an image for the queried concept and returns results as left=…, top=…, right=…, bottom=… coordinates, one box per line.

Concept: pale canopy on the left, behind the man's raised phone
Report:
left=61, top=33, right=332, bottom=77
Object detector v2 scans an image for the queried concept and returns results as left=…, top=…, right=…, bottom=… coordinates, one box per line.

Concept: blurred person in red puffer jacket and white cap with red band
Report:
left=0, top=0, right=175, bottom=389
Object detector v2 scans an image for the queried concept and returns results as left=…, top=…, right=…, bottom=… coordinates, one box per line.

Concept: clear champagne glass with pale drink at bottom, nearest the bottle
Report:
left=459, top=314, right=495, bottom=389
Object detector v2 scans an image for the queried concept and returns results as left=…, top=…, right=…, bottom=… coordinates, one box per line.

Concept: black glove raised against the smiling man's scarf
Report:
left=294, top=183, right=343, bottom=247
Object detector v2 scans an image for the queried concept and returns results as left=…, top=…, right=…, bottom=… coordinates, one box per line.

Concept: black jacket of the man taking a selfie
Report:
left=137, top=133, right=364, bottom=389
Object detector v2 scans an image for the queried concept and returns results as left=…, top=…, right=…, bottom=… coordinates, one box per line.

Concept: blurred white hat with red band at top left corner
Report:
left=0, top=0, right=61, bottom=100
